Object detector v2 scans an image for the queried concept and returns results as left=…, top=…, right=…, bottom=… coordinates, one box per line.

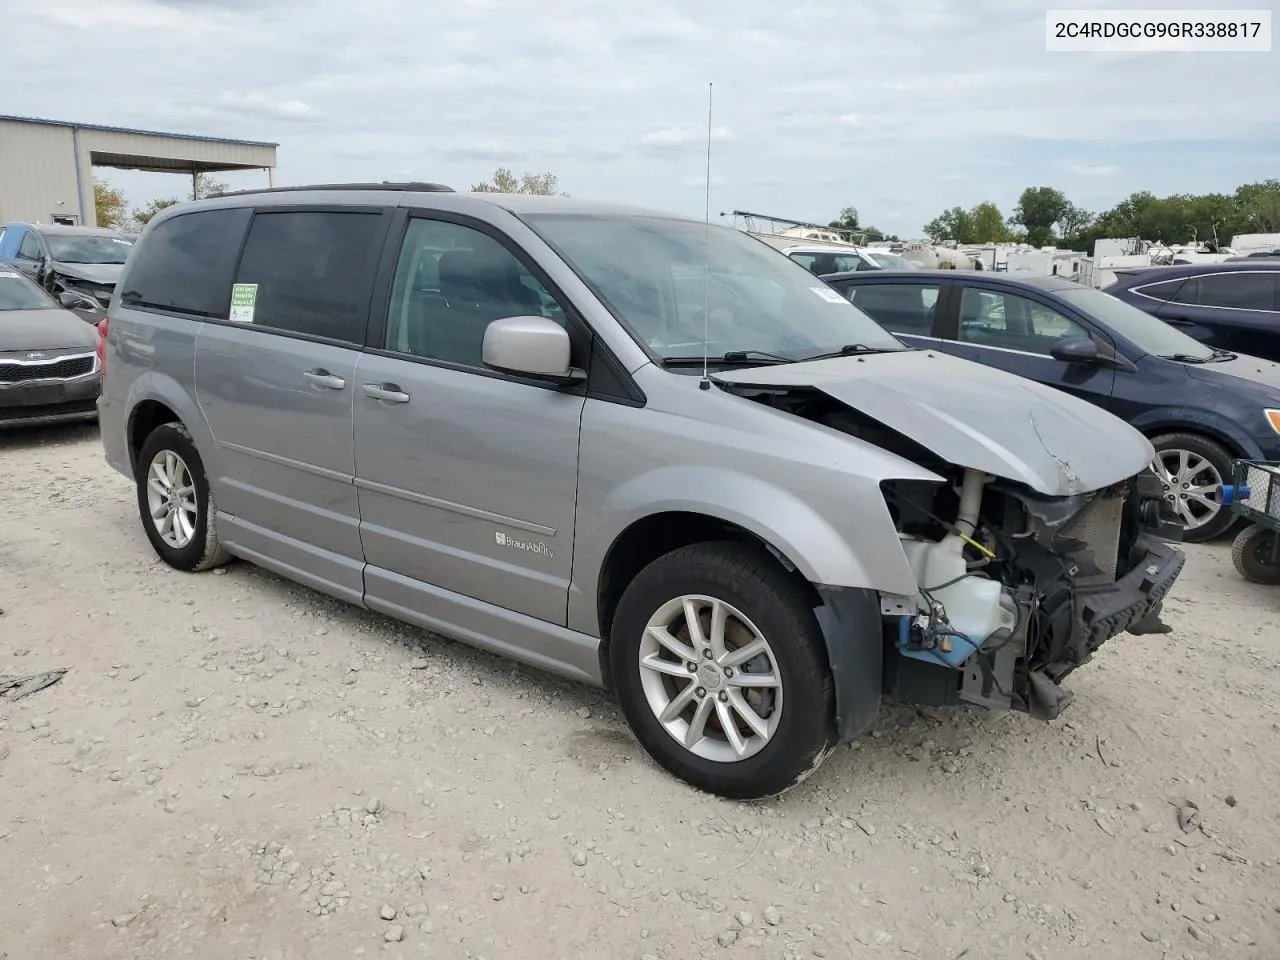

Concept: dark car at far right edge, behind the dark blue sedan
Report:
left=1103, top=257, right=1280, bottom=361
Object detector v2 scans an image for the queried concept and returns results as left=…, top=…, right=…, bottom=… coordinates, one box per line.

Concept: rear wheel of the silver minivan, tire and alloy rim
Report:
left=137, top=422, right=230, bottom=572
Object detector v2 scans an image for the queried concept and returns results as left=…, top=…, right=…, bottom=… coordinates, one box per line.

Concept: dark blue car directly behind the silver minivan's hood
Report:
left=823, top=270, right=1280, bottom=543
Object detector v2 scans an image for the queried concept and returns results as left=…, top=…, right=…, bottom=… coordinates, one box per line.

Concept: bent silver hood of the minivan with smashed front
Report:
left=716, top=351, right=1155, bottom=497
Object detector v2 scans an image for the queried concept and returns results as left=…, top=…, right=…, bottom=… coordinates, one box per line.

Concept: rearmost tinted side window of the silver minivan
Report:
left=120, top=209, right=250, bottom=319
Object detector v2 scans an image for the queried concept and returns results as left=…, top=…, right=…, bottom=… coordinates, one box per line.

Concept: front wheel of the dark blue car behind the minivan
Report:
left=1151, top=433, right=1235, bottom=543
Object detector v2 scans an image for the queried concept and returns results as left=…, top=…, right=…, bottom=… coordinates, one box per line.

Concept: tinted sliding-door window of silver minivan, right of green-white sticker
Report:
left=236, top=210, right=385, bottom=343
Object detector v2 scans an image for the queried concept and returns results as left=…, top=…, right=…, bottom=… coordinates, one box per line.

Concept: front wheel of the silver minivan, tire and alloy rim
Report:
left=609, top=541, right=836, bottom=800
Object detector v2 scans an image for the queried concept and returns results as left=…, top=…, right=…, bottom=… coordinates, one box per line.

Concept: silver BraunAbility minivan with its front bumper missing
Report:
left=100, top=184, right=1183, bottom=797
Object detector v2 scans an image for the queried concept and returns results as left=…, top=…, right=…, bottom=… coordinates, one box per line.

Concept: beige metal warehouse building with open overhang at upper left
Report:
left=0, top=115, right=279, bottom=227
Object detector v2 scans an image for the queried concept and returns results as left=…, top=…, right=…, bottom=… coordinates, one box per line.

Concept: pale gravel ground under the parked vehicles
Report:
left=0, top=428, right=1280, bottom=960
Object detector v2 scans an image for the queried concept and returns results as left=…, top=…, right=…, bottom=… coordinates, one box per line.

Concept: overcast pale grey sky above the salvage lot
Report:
left=0, top=0, right=1280, bottom=236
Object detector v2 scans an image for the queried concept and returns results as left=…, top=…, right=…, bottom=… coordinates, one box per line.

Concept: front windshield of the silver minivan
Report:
left=525, top=214, right=906, bottom=360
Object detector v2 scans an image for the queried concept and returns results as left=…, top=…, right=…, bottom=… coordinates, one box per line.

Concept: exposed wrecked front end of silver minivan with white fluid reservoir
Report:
left=815, top=477, right=1185, bottom=737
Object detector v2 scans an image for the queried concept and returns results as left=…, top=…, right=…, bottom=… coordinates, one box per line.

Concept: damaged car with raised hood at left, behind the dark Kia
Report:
left=0, top=223, right=133, bottom=324
